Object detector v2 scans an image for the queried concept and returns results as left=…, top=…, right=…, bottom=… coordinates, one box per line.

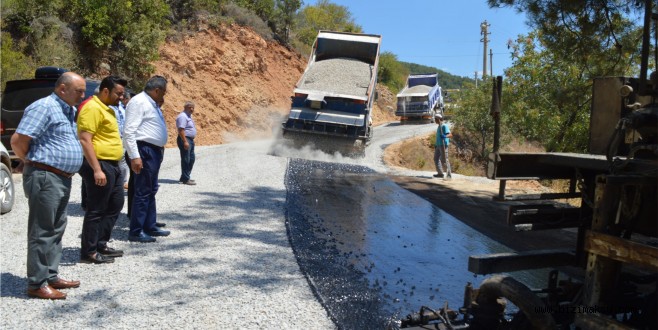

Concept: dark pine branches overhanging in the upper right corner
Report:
left=488, top=0, right=644, bottom=77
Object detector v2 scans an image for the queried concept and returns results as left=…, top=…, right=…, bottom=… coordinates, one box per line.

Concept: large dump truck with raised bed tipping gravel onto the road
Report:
left=282, top=31, right=382, bottom=150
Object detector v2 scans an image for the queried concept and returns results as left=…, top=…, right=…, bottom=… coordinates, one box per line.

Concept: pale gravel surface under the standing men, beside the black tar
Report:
left=0, top=141, right=335, bottom=329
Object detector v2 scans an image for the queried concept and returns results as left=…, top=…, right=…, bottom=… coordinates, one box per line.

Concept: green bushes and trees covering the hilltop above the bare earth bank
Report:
left=1, top=0, right=361, bottom=87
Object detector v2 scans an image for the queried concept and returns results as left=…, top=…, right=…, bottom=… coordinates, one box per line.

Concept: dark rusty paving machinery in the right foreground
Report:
left=400, top=0, right=658, bottom=329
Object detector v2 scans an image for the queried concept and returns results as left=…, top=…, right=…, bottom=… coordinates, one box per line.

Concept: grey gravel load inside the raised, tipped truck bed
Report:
left=298, top=58, right=373, bottom=96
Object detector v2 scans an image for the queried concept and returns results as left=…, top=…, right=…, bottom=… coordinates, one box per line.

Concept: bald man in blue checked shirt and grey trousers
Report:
left=11, top=72, right=86, bottom=299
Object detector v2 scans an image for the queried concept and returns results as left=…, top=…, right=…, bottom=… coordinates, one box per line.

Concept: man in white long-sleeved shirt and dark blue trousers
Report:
left=123, top=76, right=169, bottom=243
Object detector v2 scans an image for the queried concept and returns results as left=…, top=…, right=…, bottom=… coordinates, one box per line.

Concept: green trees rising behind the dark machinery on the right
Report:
left=489, top=0, right=641, bottom=152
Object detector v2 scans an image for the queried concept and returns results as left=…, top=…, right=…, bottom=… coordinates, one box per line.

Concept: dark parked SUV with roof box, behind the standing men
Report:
left=0, top=66, right=100, bottom=159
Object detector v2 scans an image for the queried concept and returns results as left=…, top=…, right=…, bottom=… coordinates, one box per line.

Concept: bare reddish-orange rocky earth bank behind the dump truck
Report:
left=154, top=25, right=395, bottom=147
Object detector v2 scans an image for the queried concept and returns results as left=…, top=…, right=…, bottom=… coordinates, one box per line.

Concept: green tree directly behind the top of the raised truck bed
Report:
left=296, top=0, right=362, bottom=47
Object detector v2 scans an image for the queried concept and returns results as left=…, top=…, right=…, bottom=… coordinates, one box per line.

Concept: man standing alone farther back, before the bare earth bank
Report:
left=176, top=101, right=196, bottom=186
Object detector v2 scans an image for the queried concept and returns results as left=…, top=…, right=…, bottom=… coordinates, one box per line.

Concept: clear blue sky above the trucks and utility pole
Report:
left=304, top=0, right=530, bottom=78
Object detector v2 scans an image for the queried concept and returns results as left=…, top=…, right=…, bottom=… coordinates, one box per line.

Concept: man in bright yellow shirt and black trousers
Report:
left=78, top=76, right=127, bottom=264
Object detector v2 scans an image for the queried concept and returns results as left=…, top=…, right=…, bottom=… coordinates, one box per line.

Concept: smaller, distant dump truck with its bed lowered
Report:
left=395, top=73, right=443, bottom=121
